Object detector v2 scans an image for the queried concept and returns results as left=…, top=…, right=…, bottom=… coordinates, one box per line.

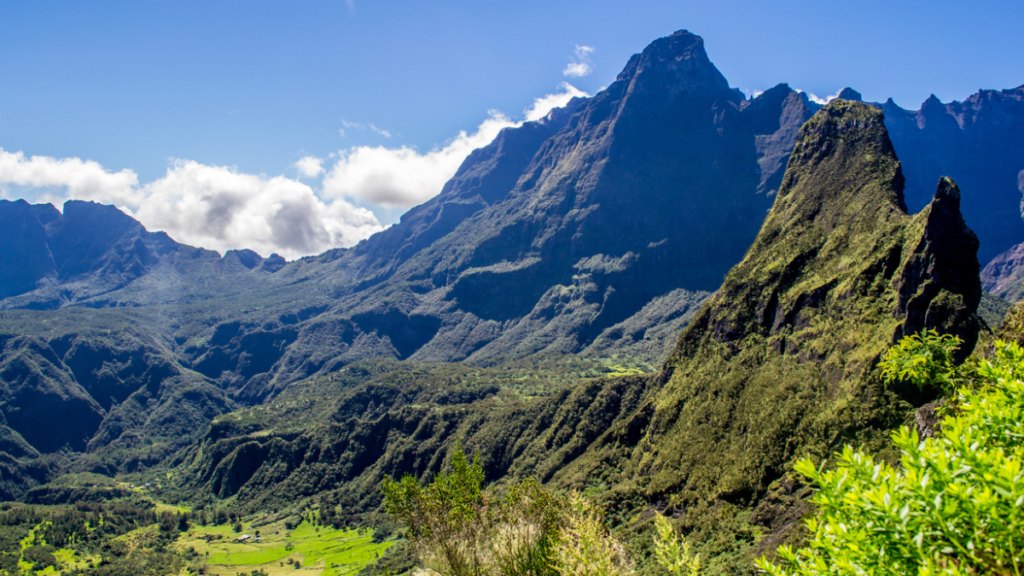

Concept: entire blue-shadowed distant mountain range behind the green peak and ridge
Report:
left=0, top=31, right=1024, bottom=496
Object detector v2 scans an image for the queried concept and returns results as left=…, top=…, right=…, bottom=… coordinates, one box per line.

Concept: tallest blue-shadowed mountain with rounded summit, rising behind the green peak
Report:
left=313, top=32, right=811, bottom=362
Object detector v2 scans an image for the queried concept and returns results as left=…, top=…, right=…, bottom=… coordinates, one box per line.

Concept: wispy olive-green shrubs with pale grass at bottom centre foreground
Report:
left=383, top=447, right=629, bottom=576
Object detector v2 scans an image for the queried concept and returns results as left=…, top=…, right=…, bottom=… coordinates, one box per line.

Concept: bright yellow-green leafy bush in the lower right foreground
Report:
left=758, top=333, right=1024, bottom=576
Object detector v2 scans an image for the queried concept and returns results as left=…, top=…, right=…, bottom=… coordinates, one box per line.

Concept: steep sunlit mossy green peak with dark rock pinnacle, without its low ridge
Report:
left=623, top=100, right=983, bottom=532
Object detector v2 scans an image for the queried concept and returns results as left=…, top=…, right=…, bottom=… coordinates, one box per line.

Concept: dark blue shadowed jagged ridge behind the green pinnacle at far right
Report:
left=881, top=86, right=1024, bottom=263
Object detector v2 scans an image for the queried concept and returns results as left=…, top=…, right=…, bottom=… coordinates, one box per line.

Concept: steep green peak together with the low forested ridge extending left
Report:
left=171, top=99, right=984, bottom=574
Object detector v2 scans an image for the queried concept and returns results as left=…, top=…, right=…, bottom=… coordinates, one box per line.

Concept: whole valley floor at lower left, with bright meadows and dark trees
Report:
left=0, top=496, right=394, bottom=576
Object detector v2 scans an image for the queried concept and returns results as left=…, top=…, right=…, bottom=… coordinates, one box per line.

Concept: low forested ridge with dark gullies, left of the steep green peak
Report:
left=162, top=356, right=651, bottom=510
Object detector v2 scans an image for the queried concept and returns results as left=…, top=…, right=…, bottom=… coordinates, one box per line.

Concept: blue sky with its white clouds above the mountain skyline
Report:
left=0, top=0, right=1024, bottom=257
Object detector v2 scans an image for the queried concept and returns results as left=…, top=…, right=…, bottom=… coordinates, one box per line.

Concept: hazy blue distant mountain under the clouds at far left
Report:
left=0, top=194, right=285, bottom=310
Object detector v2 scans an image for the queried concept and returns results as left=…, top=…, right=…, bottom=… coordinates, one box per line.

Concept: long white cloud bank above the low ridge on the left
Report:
left=0, top=149, right=383, bottom=259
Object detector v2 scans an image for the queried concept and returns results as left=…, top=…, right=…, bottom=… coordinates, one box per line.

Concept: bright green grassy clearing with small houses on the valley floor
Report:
left=176, top=522, right=393, bottom=576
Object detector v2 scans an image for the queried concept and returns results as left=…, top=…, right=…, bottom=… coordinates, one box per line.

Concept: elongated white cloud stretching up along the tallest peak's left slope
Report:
left=324, top=83, right=587, bottom=208
